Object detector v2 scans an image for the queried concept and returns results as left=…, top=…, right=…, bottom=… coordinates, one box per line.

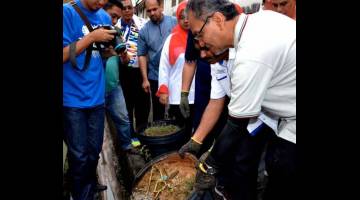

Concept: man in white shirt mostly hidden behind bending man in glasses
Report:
left=179, top=45, right=277, bottom=199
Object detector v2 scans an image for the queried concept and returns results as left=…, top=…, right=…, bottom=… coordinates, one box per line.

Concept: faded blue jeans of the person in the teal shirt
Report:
left=105, top=85, right=132, bottom=150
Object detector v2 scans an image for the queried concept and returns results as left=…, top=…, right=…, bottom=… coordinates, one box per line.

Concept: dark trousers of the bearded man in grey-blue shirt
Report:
left=149, top=80, right=165, bottom=121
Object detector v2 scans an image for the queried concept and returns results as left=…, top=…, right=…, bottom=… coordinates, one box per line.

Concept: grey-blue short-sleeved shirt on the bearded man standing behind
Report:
left=138, top=15, right=177, bottom=80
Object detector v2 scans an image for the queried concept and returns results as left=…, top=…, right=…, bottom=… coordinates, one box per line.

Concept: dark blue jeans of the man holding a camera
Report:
left=63, top=105, right=105, bottom=200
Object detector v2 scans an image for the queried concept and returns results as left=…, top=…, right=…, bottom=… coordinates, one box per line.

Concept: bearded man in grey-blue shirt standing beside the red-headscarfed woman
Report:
left=138, top=0, right=177, bottom=121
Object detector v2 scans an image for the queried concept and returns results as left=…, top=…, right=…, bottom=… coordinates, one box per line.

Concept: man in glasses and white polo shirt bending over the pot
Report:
left=187, top=0, right=296, bottom=199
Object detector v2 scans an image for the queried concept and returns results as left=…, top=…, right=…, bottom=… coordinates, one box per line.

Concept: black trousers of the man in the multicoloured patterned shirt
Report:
left=120, top=66, right=150, bottom=135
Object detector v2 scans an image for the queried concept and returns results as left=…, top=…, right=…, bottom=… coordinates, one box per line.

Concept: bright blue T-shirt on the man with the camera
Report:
left=63, top=0, right=112, bottom=108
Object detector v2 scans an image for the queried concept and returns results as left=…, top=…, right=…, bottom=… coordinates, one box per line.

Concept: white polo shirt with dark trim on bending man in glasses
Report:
left=228, top=10, right=296, bottom=143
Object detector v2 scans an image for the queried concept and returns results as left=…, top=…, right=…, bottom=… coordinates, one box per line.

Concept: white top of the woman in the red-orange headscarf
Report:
left=159, top=34, right=195, bottom=105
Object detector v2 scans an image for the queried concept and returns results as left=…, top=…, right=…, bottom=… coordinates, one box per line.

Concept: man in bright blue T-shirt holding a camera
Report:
left=63, top=0, right=114, bottom=200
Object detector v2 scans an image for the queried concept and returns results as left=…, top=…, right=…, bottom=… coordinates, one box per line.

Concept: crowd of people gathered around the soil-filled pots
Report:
left=63, top=0, right=297, bottom=200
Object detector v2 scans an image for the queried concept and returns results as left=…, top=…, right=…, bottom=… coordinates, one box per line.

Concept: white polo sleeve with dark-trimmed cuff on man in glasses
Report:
left=228, top=60, right=273, bottom=118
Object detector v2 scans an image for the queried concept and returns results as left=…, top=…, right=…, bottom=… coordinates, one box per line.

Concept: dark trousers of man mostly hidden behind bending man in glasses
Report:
left=210, top=119, right=272, bottom=200
